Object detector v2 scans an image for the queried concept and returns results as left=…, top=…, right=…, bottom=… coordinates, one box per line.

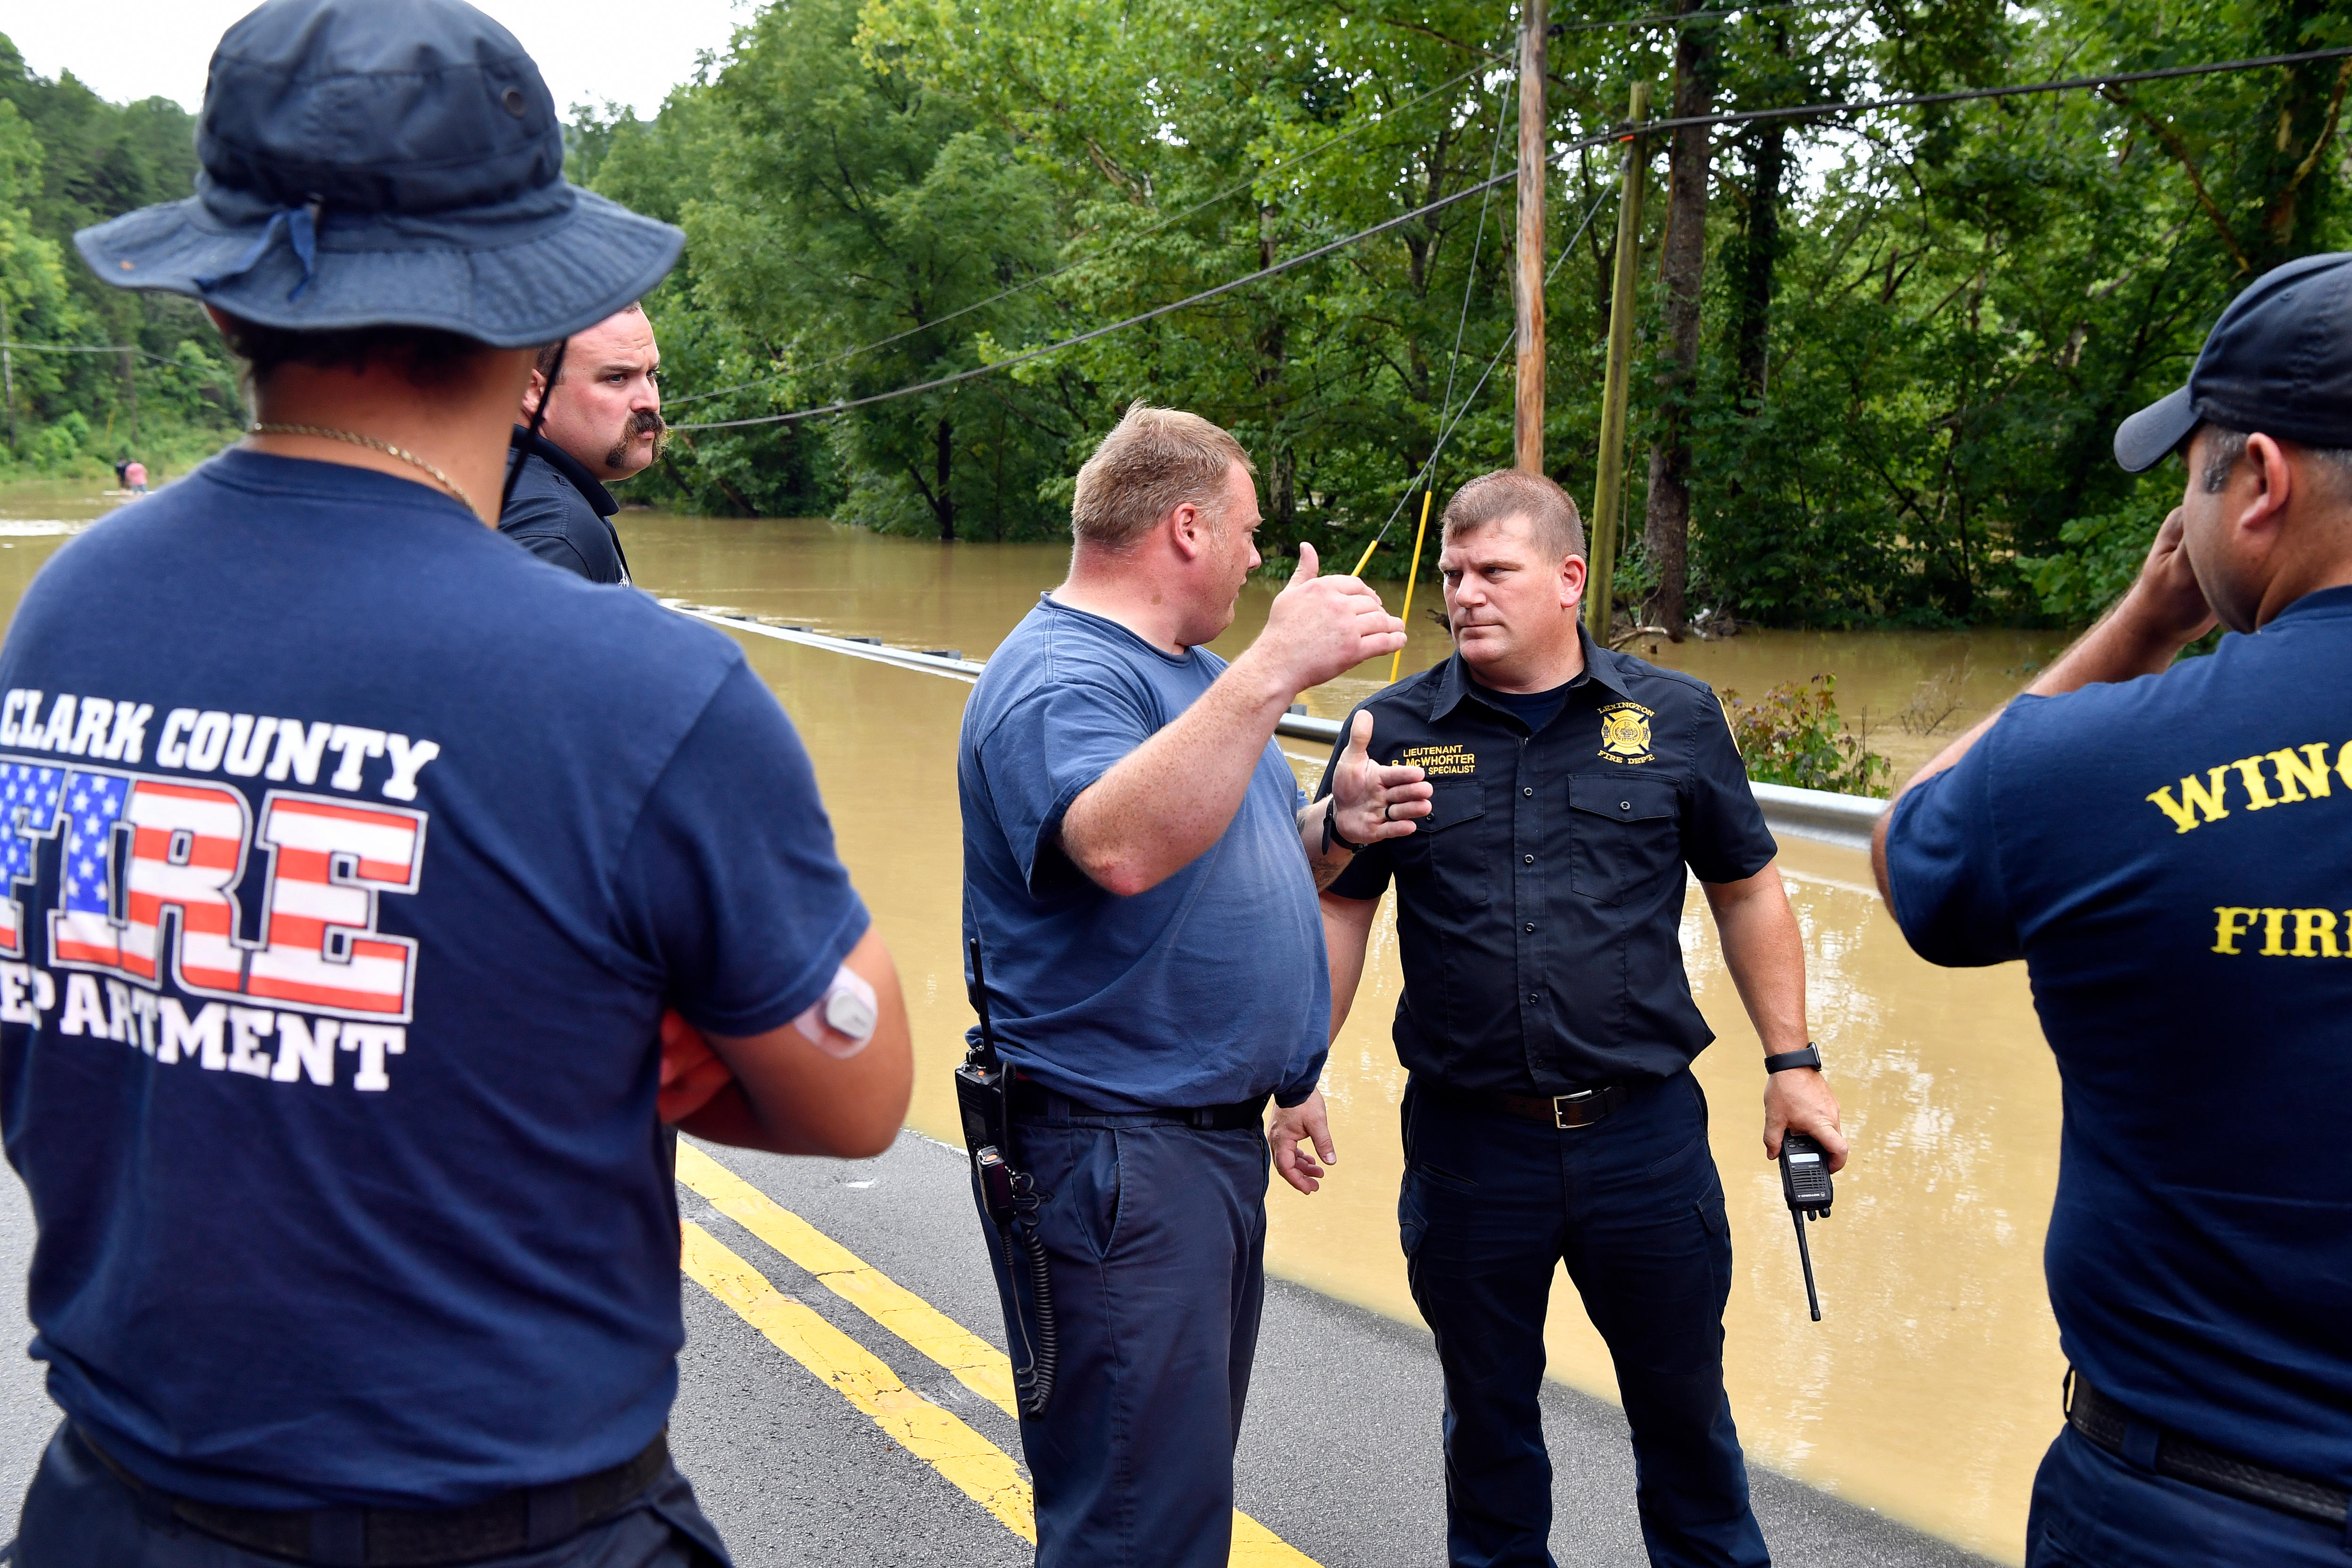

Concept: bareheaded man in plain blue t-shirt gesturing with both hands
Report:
left=957, top=404, right=1430, bottom=1568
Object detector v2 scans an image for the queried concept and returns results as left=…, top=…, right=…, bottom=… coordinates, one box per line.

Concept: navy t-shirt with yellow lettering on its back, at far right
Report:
left=1886, top=588, right=2352, bottom=1486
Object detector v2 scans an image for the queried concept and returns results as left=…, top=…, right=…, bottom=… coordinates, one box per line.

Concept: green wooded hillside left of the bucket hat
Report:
left=0, top=38, right=238, bottom=472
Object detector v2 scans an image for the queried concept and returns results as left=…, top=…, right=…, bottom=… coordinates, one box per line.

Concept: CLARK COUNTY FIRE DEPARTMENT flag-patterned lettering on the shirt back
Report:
left=0, top=689, right=440, bottom=1093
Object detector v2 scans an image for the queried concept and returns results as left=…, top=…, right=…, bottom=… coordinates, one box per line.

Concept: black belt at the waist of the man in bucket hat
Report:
left=73, top=1427, right=670, bottom=1568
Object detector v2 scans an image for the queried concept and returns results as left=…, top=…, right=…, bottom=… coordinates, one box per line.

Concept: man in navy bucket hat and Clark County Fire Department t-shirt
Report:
left=0, top=0, right=910, bottom=1568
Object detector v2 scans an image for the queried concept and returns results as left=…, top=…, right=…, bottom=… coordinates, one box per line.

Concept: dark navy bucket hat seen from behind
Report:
left=73, top=0, right=684, bottom=348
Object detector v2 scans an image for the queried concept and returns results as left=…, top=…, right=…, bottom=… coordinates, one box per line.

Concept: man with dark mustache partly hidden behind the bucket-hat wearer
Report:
left=499, top=306, right=668, bottom=583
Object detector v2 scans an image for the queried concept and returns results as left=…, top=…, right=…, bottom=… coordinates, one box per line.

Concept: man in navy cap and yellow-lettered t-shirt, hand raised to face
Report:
left=1877, top=254, right=2352, bottom=1568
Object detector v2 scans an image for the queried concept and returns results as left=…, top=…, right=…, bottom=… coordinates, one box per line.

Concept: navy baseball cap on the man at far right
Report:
left=2114, top=252, right=2352, bottom=472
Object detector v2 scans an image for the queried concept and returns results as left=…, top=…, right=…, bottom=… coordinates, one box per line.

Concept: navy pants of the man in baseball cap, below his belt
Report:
left=2025, top=1427, right=2352, bottom=1568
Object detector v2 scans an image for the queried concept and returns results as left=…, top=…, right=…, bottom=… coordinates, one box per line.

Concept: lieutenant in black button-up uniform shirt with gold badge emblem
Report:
left=1317, top=472, right=1846, bottom=1568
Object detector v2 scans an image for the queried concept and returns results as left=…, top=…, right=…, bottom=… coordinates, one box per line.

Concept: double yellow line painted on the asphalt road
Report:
left=677, top=1143, right=1317, bottom=1568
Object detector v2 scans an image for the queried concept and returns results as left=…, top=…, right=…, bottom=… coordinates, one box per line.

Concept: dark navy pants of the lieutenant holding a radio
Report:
left=1397, top=1072, right=1771, bottom=1568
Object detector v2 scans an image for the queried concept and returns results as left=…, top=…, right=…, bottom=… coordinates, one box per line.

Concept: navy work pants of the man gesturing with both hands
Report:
left=981, top=1098, right=1268, bottom=1568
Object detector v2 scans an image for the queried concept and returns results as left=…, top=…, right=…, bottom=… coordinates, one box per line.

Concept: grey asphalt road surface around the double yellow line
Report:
left=0, top=1133, right=1983, bottom=1568
